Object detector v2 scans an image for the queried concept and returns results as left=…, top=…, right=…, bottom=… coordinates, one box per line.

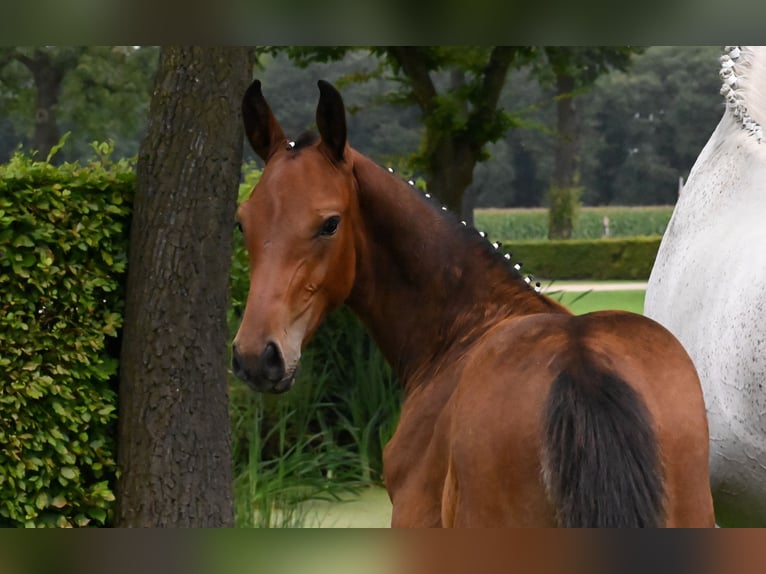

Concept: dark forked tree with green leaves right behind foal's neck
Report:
left=280, top=46, right=536, bottom=225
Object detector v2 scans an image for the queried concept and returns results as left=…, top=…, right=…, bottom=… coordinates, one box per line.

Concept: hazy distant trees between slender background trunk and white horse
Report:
left=582, top=46, right=724, bottom=205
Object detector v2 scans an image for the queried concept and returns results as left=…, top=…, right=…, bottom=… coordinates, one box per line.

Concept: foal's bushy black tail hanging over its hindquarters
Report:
left=543, top=372, right=665, bottom=528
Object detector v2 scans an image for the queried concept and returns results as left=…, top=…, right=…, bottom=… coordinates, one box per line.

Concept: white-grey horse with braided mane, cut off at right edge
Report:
left=644, top=46, right=766, bottom=526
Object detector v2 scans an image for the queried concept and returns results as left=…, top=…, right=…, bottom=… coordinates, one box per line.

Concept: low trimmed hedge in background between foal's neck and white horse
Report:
left=503, top=236, right=662, bottom=280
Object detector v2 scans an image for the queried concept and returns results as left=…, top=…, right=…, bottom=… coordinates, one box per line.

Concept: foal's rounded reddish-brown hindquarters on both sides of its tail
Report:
left=396, top=312, right=714, bottom=526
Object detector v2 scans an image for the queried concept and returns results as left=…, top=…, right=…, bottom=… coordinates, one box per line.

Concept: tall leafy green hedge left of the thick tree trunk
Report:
left=0, top=145, right=135, bottom=526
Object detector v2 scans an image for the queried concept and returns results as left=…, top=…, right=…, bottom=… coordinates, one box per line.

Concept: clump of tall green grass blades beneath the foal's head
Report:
left=231, top=309, right=400, bottom=527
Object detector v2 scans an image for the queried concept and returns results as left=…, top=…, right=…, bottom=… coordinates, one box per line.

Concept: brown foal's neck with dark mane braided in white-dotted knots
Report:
left=348, top=152, right=566, bottom=390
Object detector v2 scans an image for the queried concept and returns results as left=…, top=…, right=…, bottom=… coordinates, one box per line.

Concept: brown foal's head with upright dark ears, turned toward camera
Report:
left=233, top=80, right=358, bottom=392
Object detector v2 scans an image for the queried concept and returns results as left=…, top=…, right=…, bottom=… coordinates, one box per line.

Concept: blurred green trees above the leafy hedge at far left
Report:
left=0, top=46, right=158, bottom=160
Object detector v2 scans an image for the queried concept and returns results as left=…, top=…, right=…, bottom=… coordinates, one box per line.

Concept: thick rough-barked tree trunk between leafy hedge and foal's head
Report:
left=116, top=47, right=253, bottom=527
